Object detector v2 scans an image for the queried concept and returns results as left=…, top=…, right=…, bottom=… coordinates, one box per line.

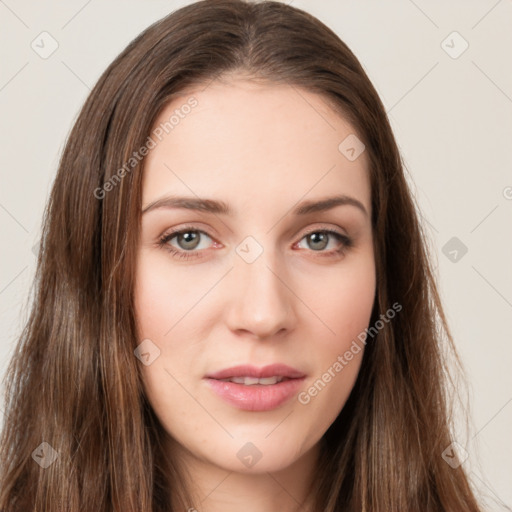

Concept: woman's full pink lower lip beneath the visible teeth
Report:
left=206, top=377, right=304, bottom=411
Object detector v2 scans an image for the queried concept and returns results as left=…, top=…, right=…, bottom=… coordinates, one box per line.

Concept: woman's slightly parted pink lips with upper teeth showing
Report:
left=205, top=364, right=306, bottom=412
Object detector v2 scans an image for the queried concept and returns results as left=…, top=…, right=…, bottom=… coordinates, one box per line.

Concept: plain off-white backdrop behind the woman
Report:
left=0, top=0, right=512, bottom=510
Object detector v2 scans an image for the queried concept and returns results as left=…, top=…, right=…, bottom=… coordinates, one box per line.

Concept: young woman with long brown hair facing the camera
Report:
left=0, top=0, right=480, bottom=512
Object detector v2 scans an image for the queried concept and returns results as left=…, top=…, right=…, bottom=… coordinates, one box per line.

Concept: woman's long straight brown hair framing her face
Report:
left=0, top=0, right=480, bottom=512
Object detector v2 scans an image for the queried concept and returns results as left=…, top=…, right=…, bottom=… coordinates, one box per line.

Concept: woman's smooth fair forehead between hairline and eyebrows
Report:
left=143, top=79, right=371, bottom=216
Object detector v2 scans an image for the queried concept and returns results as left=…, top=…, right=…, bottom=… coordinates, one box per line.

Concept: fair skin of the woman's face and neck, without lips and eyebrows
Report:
left=135, top=76, right=376, bottom=512
